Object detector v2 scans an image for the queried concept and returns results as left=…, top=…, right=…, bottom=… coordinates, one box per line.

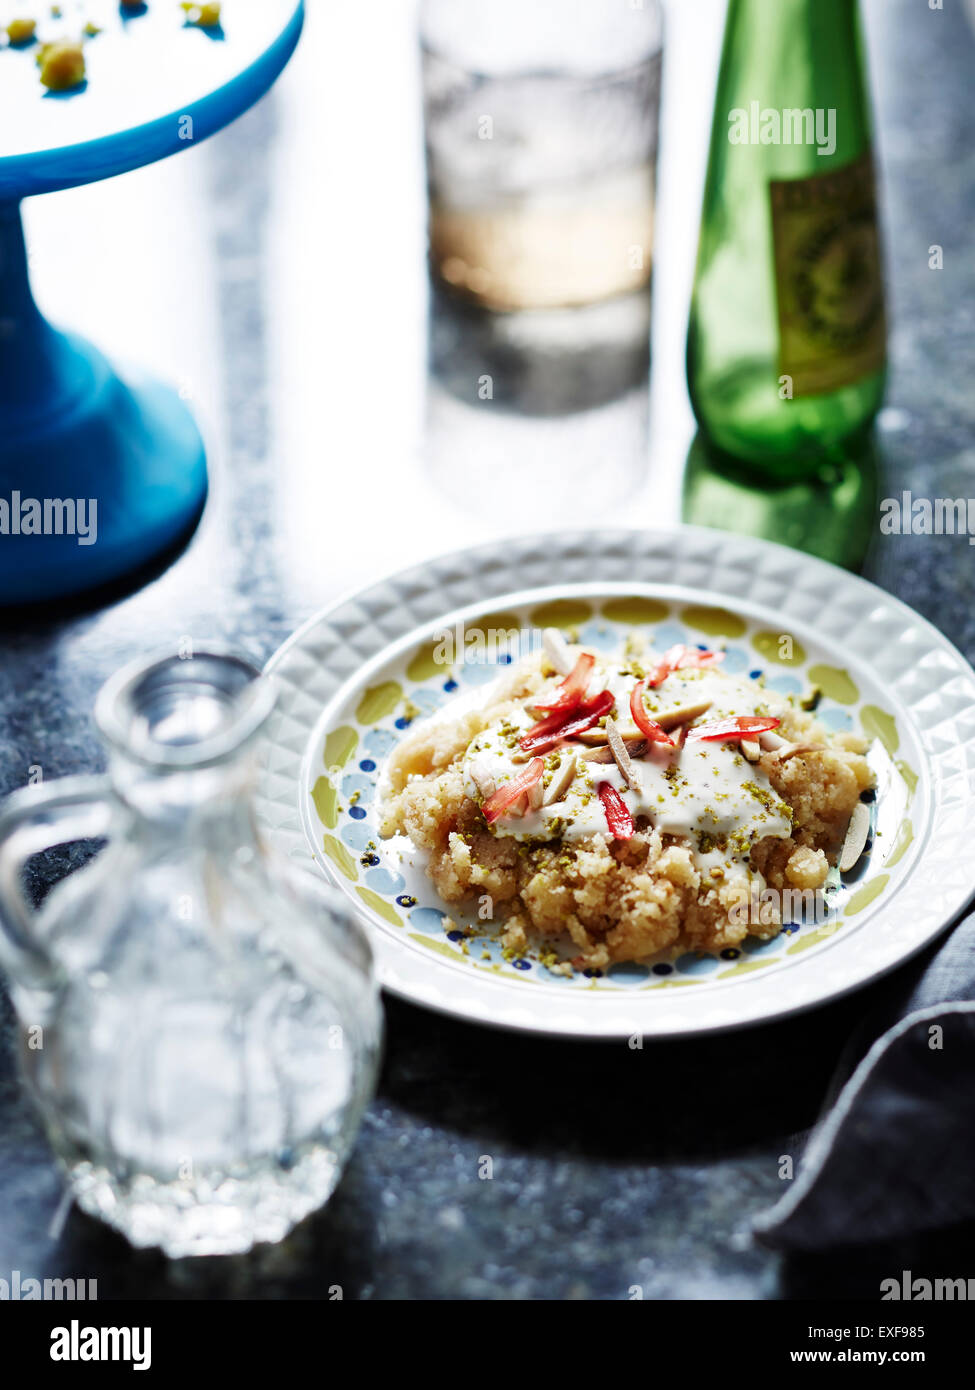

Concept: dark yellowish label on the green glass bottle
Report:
left=769, top=150, right=886, bottom=396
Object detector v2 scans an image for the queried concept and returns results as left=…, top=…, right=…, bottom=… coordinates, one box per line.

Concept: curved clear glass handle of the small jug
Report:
left=0, top=777, right=114, bottom=988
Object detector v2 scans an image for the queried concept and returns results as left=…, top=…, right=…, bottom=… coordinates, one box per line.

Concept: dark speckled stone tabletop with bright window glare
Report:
left=0, top=0, right=975, bottom=1300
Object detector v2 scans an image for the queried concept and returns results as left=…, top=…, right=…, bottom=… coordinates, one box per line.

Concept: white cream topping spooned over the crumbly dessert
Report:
left=465, top=657, right=791, bottom=867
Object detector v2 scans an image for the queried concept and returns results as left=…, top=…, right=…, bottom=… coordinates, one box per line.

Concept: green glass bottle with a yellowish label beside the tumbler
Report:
left=687, top=0, right=886, bottom=478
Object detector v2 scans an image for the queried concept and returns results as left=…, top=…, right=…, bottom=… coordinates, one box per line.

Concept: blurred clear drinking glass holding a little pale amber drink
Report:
left=420, top=0, right=662, bottom=310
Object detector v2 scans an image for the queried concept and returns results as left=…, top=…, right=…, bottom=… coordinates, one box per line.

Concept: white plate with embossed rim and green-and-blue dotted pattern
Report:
left=257, top=527, right=975, bottom=1038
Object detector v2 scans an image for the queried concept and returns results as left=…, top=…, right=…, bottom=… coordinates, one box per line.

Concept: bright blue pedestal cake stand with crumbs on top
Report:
left=0, top=0, right=303, bottom=606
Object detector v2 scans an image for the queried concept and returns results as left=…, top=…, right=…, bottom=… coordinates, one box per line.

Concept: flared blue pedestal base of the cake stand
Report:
left=0, top=204, right=207, bottom=606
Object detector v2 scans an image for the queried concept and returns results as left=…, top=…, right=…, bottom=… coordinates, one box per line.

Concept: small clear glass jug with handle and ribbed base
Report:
left=0, top=649, right=382, bottom=1257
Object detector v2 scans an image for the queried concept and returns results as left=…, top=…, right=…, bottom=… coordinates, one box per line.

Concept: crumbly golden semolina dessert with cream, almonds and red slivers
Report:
left=381, top=630, right=873, bottom=973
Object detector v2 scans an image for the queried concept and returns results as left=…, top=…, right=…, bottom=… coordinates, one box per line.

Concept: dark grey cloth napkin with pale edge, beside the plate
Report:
left=754, top=913, right=975, bottom=1252
